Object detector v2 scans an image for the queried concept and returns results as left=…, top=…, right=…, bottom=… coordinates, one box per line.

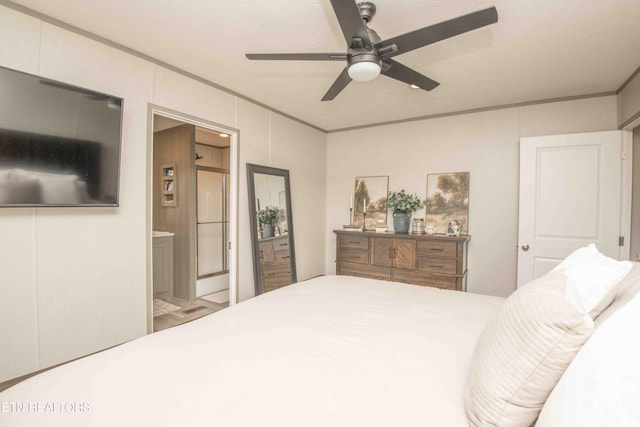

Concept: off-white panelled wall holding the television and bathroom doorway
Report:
left=0, top=7, right=326, bottom=382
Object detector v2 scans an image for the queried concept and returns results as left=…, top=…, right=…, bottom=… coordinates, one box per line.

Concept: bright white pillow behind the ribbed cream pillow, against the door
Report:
left=551, top=243, right=631, bottom=319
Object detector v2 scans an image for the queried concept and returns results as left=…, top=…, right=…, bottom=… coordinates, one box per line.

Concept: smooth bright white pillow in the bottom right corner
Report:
left=536, top=295, right=640, bottom=427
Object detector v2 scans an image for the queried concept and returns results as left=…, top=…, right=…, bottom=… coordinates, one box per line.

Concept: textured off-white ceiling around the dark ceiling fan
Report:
left=8, top=0, right=640, bottom=131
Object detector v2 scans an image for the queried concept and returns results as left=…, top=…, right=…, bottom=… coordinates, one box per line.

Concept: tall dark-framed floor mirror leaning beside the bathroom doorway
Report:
left=247, top=164, right=297, bottom=295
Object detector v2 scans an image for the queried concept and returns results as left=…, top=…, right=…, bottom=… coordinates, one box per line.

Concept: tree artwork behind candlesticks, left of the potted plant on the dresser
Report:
left=351, top=176, right=389, bottom=230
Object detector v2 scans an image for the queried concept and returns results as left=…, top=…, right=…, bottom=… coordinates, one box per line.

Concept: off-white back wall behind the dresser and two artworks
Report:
left=325, top=96, right=618, bottom=296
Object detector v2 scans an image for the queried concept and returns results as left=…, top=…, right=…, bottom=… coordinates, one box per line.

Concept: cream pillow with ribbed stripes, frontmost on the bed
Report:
left=465, top=272, right=593, bottom=427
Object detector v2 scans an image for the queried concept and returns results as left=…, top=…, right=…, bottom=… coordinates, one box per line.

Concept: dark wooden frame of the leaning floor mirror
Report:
left=247, top=163, right=298, bottom=295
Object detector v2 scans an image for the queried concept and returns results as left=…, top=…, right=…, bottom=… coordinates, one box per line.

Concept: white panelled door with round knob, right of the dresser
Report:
left=517, top=131, right=624, bottom=287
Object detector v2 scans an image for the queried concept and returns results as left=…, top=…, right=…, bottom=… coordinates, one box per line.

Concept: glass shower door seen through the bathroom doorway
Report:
left=196, top=167, right=229, bottom=279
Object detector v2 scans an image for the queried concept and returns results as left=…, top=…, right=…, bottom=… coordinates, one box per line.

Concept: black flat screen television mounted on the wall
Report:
left=0, top=67, right=123, bottom=207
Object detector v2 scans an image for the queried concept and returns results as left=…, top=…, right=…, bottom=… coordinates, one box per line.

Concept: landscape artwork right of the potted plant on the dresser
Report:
left=425, top=172, right=469, bottom=236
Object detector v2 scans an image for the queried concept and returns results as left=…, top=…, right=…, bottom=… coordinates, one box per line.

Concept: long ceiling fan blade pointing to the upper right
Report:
left=374, top=7, right=498, bottom=58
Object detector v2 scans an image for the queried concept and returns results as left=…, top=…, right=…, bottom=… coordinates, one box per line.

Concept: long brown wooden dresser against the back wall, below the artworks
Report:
left=334, top=230, right=471, bottom=291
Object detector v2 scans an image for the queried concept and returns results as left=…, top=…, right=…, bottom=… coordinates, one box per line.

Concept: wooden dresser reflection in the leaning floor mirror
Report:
left=260, top=235, right=291, bottom=292
